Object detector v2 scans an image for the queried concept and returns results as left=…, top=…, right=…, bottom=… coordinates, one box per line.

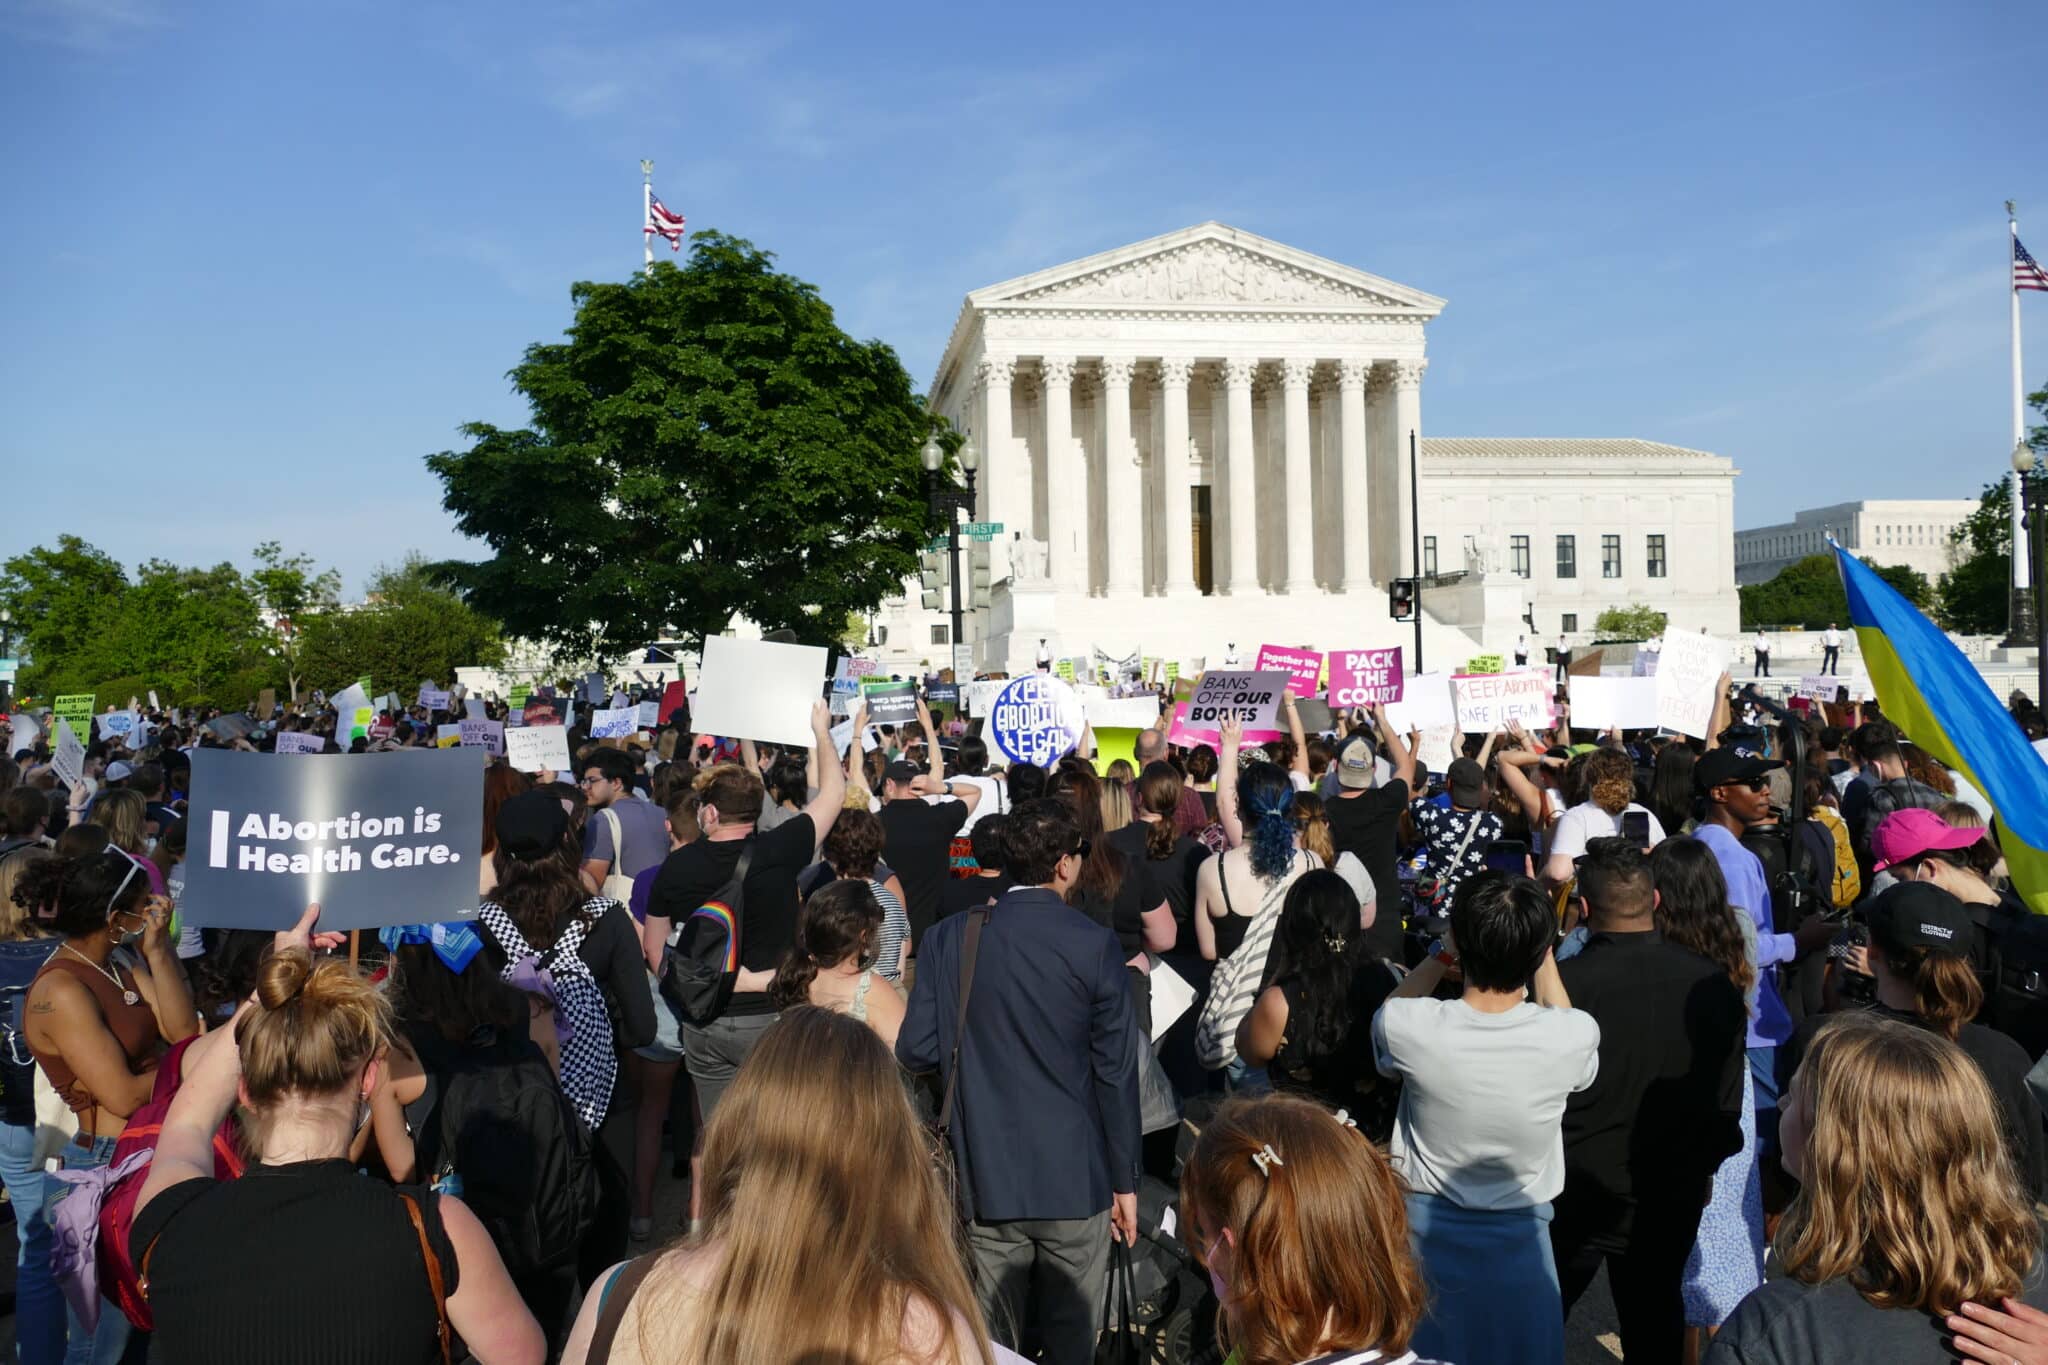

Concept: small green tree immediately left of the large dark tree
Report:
left=299, top=555, right=506, bottom=692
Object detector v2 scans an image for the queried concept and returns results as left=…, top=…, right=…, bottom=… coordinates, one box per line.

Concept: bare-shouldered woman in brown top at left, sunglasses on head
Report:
left=16, top=845, right=199, bottom=1363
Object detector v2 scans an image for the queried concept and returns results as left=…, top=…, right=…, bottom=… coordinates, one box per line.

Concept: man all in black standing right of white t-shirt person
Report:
left=1550, top=837, right=1749, bottom=1361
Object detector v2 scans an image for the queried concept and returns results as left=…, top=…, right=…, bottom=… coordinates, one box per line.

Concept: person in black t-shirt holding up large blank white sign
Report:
left=645, top=702, right=851, bottom=1121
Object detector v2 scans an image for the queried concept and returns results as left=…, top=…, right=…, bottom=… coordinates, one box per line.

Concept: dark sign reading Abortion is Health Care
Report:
left=178, top=749, right=485, bottom=929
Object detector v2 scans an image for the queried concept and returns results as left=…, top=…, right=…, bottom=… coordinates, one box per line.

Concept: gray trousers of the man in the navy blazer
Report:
left=967, top=1209, right=1110, bottom=1361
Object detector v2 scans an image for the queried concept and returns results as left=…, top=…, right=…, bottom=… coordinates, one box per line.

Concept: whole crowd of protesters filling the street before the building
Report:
left=0, top=663, right=2048, bottom=1365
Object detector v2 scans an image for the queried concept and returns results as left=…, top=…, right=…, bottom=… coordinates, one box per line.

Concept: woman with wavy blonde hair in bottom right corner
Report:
left=1706, top=1011, right=2048, bottom=1365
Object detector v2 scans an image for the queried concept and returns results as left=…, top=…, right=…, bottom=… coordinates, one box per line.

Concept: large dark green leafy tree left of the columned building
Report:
left=426, top=231, right=934, bottom=659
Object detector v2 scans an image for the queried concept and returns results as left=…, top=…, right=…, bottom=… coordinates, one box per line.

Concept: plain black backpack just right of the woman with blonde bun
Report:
left=412, top=1029, right=598, bottom=1277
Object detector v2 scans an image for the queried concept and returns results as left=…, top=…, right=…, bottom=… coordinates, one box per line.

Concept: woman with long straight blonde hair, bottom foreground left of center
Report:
left=561, top=1005, right=1012, bottom=1365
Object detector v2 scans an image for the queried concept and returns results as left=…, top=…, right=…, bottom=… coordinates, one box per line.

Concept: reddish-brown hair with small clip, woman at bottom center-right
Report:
left=1180, top=1095, right=1449, bottom=1365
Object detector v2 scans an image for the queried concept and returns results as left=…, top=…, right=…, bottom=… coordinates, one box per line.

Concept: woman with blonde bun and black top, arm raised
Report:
left=129, top=907, right=547, bottom=1365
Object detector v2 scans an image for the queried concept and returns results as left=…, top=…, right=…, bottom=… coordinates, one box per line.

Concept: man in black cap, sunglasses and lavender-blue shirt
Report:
left=1692, top=747, right=1833, bottom=1158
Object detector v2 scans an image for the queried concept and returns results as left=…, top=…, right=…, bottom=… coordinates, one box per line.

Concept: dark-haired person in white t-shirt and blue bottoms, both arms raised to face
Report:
left=1372, top=872, right=1599, bottom=1365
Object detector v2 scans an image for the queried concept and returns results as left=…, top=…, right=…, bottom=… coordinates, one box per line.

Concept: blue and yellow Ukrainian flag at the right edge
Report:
left=1829, top=542, right=2048, bottom=915
